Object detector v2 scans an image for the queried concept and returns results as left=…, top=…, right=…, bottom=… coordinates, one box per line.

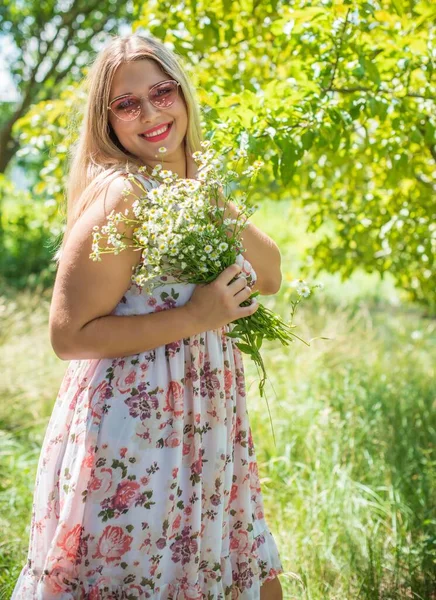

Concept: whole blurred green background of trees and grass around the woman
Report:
left=0, top=0, right=436, bottom=600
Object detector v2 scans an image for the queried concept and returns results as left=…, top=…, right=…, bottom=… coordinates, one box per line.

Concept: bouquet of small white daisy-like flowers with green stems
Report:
left=90, top=141, right=320, bottom=438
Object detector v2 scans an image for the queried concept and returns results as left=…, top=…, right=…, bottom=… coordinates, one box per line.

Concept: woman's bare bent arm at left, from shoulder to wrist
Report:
left=49, top=178, right=204, bottom=360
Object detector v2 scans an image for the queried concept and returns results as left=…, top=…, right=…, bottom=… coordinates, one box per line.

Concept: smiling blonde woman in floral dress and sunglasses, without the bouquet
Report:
left=12, top=35, right=283, bottom=600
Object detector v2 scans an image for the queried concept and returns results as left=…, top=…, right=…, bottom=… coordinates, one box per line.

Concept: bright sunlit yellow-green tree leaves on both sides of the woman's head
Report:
left=6, top=0, right=436, bottom=313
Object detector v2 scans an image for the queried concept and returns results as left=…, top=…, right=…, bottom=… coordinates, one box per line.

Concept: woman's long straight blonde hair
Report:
left=54, top=34, right=202, bottom=262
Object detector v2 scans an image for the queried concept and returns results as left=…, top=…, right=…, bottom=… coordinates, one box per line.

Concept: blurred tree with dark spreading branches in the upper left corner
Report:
left=0, top=0, right=132, bottom=173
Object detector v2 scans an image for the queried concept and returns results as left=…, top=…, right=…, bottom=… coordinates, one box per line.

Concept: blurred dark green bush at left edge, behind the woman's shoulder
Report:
left=0, top=175, right=60, bottom=289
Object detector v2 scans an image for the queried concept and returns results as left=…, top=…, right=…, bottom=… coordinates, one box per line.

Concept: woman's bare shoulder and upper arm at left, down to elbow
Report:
left=49, top=176, right=150, bottom=355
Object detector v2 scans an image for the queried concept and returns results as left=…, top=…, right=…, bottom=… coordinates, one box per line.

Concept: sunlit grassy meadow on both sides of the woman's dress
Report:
left=0, top=202, right=436, bottom=600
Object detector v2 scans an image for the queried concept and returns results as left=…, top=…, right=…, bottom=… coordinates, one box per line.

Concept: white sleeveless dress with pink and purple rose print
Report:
left=11, top=178, right=283, bottom=600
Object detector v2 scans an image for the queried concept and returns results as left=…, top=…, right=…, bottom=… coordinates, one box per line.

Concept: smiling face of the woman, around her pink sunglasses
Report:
left=108, top=59, right=188, bottom=177
